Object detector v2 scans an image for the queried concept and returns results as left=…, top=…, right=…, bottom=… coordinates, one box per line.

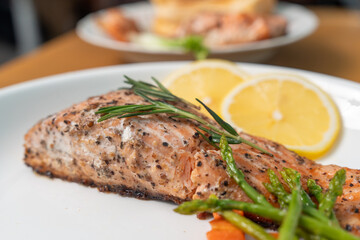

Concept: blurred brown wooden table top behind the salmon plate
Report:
left=0, top=7, right=360, bottom=88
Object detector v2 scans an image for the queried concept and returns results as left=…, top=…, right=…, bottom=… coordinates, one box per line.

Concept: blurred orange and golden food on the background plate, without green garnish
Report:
left=98, top=0, right=287, bottom=48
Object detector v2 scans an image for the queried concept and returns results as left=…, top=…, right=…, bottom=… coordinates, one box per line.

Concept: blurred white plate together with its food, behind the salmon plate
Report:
left=76, top=0, right=317, bottom=62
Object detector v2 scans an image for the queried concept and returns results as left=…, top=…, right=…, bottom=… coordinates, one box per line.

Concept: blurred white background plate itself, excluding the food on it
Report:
left=76, top=3, right=318, bottom=62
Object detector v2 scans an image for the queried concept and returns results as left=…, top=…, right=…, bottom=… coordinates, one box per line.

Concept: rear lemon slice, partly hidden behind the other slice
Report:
left=163, top=60, right=249, bottom=113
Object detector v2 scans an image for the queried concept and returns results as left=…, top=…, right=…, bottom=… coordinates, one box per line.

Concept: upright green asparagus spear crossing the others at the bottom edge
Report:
left=279, top=173, right=302, bottom=240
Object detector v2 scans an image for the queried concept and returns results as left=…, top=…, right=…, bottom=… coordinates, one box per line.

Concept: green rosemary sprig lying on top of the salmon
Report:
left=96, top=76, right=272, bottom=156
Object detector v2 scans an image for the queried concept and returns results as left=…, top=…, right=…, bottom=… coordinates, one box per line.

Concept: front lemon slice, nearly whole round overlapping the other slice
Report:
left=222, top=74, right=341, bottom=159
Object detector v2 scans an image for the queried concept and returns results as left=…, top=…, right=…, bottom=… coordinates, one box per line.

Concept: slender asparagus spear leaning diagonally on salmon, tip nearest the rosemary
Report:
left=220, top=135, right=273, bottom=207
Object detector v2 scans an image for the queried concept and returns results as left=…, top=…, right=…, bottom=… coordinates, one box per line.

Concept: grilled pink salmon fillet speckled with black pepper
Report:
left=24, top=90, right=360, bottom=235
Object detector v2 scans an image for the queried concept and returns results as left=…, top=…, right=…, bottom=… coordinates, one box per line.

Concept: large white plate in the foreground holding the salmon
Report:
left=0, top=62, right=360, bottom=240
